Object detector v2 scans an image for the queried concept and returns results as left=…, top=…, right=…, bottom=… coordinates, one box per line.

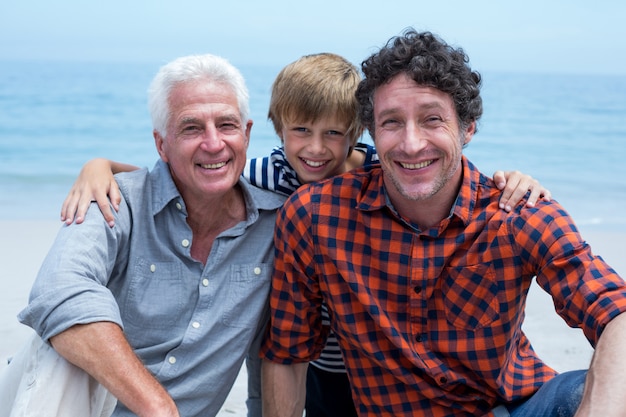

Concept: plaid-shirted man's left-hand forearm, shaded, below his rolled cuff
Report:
left=261, top=360, right=308, bottom=417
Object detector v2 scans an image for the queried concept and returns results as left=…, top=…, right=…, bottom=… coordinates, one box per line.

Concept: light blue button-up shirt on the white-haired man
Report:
left=19, top=161, right=284, bottom=417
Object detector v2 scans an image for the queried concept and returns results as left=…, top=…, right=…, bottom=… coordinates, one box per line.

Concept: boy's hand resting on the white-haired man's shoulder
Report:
left=61, top=158, right=138, bottom=227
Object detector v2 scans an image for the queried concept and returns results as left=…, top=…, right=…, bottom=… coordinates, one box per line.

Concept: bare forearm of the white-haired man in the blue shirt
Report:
left=50, top=322, right=179, bottom=417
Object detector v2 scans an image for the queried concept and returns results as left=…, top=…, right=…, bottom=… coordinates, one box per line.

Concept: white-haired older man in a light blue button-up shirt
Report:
left=0, top=55, right=284, bottom=417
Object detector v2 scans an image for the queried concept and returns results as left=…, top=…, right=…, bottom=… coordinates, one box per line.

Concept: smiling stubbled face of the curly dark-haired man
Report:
left=374, top=74, right=475, bottom=209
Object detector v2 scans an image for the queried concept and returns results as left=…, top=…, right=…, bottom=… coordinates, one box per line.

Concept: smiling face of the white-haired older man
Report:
left=154, top=80, right=252, bottom=204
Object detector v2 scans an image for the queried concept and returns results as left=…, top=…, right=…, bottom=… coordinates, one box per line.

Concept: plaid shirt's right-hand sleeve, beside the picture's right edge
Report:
left=510, top=202, right=626, bottom=347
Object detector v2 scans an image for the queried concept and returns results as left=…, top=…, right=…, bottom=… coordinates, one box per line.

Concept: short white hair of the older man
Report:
left=148, top=54, right=250, bottom=137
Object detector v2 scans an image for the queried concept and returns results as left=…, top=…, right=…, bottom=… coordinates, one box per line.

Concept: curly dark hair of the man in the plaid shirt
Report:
left=356, top=28, right=483, bottom=137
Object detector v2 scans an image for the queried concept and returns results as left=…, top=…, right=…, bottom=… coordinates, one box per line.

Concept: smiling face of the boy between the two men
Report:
left=281, top=117, right=351, bottom=184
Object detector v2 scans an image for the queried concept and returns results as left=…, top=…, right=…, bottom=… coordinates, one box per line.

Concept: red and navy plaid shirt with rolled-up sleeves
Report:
left=262, top=158, right=626, bottom=417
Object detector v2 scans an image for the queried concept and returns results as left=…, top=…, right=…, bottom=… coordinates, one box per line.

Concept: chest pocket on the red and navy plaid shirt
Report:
left=441, top=264, right=500, bottom=330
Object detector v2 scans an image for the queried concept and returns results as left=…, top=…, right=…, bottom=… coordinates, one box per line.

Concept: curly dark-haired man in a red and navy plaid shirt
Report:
left=262, top=30, right=626, bottom=417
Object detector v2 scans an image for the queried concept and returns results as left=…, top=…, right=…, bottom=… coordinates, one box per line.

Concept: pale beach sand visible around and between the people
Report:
left=0, top=220, right=626, bottom=416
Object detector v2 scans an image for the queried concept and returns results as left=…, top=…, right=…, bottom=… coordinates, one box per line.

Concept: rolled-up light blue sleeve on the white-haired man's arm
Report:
left=18, top=204, right=128, bottom=341
